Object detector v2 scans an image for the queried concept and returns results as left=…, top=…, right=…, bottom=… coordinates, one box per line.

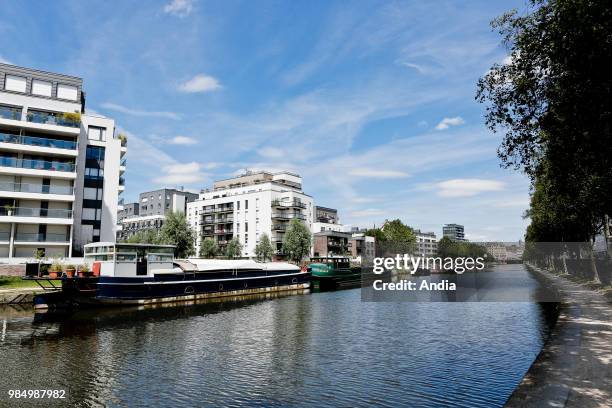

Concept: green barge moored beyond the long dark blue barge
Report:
left=309, top=256, right=361, bottom=291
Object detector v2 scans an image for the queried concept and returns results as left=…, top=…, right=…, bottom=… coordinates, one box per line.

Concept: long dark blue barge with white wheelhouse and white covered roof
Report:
left=34, top=242, right=310, bottom=309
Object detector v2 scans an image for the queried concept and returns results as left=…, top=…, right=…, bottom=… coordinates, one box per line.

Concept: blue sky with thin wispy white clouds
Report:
left=0, top=0, right=529, bottom=240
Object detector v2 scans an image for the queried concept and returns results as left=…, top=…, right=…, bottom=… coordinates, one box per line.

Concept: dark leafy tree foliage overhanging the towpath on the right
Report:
left=476, top=0, right=612, bottom=241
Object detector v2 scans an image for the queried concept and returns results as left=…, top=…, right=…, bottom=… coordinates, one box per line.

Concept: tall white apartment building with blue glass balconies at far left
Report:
left=0, top=63, right=127, bottom=258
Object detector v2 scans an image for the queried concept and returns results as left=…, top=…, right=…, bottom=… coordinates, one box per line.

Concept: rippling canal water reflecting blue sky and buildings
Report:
left=0, top=265, right=551, bottom=407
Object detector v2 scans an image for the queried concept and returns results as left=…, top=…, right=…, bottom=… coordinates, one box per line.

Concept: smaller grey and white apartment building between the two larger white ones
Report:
left=117, top=188, right=198, bottom=240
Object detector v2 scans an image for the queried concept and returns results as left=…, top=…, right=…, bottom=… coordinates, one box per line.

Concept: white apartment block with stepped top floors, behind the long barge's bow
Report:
left=187, top=171, right=314, bottom=257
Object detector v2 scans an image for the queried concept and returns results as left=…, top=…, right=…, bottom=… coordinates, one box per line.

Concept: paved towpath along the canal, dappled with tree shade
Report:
left=506, top=266, right=612, bottom=408
